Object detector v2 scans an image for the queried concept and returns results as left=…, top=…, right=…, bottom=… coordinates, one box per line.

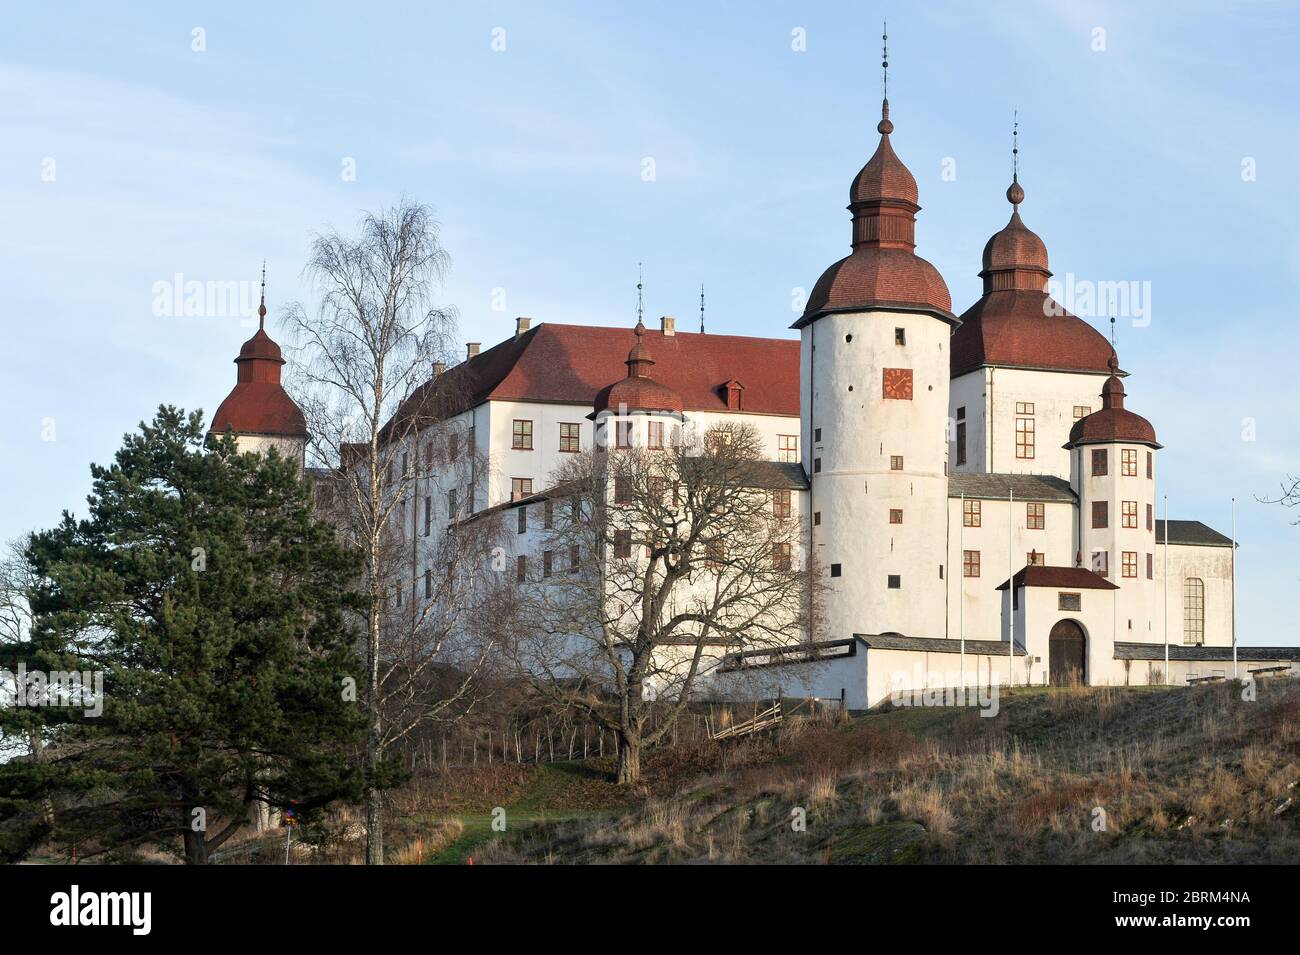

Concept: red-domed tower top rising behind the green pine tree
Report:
left=209, top=268, right=307, bottom=464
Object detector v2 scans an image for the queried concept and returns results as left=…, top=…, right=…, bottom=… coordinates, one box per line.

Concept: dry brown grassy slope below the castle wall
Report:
left=437, top=681, right=1300, bottom=863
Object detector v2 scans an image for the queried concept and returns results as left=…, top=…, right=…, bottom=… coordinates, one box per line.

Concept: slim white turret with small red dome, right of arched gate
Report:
left=1065, top=355, right=1161, bottom=642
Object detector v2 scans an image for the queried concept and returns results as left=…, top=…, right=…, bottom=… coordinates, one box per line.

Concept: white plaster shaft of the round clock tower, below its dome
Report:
left=800, top=311, right=949, bottom=639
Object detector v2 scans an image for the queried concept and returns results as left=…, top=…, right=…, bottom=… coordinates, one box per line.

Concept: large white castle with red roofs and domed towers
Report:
left=213, top=100, right=1300, bottom=708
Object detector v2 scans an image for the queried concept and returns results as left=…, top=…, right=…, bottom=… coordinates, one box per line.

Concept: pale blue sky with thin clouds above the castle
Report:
left=0, top=0, right=1300, bottom=643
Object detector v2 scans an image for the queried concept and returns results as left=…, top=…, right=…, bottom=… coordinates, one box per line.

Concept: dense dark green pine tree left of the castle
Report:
left=0, top=407, right=377, bottom=864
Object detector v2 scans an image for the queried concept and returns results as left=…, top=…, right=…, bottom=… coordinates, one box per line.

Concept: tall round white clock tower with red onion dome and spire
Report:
left=794, top=26, right=956, bottom=639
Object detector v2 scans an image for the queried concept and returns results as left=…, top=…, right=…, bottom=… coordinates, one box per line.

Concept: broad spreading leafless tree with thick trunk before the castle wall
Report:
left=515, top=424, right=819, bottom=783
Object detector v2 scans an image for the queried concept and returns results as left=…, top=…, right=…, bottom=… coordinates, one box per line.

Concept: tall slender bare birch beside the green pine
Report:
left=290, top=199, right=495, bottom=865
